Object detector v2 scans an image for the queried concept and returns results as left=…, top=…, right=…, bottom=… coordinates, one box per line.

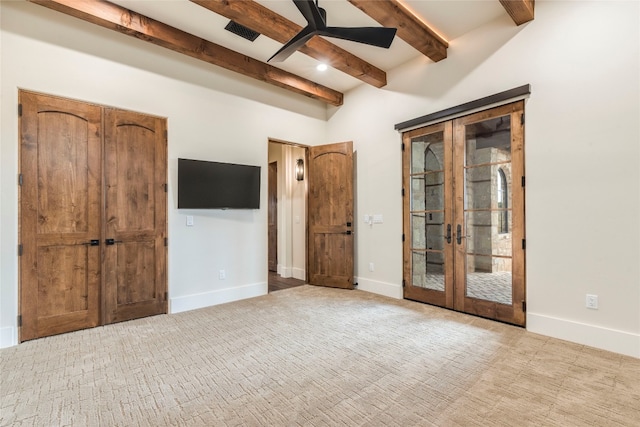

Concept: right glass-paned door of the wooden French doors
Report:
left=454, top=102, right=525, bottom=325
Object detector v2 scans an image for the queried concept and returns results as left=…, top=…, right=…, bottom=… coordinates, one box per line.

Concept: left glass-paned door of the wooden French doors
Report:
left=403, top=123, right=453, bottom=308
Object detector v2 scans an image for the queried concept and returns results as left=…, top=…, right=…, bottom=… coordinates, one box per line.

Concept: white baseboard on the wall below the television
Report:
left=169, top=282, right=268, bottom=314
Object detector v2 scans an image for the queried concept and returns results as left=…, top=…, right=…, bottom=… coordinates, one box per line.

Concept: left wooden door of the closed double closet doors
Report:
left=19, top=91, right=102, bottom=341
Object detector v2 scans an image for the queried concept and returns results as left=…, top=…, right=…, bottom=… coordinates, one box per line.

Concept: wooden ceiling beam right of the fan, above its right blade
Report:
left=349, top=0, right=449, bottom=62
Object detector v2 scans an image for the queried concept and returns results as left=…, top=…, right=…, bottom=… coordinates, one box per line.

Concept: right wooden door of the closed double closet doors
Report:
left=103, top=109, right=167, bottom=324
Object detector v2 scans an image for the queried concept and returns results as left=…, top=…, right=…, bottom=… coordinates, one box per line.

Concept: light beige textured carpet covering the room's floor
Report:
left=0, top=286, right=640, bottom=426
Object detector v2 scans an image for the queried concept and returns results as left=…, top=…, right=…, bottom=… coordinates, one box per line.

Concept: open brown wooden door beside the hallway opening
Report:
left=308, top=142, right=354, bottom=289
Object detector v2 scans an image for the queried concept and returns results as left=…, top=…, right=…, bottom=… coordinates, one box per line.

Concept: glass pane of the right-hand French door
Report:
left=464, top=116, right=513, bottom=305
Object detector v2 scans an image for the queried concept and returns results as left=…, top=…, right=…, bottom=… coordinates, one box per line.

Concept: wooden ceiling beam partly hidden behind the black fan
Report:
left=190, top=0, right=387, bottom=88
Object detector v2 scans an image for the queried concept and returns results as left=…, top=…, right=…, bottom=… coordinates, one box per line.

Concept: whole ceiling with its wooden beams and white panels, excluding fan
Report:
left=30, top=0, right=535, bottom=105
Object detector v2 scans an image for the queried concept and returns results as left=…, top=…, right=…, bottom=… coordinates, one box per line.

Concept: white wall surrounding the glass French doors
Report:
left=328, top=1, right=640, bottom=357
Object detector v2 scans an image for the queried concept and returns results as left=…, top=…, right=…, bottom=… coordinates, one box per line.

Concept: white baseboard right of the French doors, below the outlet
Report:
left=527, top=313, right=640, bottom=358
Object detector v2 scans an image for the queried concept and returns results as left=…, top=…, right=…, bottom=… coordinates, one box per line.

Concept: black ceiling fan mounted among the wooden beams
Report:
left=267, top=0, right=396, bottom=62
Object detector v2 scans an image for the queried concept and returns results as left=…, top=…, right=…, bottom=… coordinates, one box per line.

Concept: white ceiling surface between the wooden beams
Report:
left=110, top=0, right=515, bottom=92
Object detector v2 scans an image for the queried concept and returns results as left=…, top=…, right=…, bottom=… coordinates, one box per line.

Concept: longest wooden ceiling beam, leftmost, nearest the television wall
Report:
left=29, top=0, right=344, bottom=106
